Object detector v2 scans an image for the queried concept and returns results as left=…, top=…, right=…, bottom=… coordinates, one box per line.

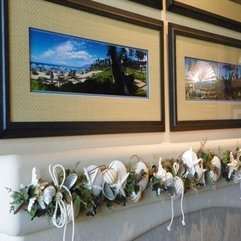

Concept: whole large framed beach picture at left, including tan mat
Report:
left=0, top=0, right=165, bottom=138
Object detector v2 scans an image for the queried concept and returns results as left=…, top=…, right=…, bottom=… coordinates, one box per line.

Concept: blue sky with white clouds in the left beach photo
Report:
left=29, top=28, right=107, bottom=67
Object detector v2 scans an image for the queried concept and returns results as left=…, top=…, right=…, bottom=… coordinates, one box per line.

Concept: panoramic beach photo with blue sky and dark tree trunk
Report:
left=29, top=28, right=149, bottom=98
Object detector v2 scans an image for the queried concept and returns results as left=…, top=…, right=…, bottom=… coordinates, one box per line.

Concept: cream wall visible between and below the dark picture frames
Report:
left=0, top=0, right=241, bottom=154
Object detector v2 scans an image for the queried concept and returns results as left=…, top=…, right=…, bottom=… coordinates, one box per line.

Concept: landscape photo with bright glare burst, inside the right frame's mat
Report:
left=185, top=57, right=241, bottom=101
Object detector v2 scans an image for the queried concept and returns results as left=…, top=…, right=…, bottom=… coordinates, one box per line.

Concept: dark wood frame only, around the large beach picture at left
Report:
left=0, top=0, right=165, bottom=138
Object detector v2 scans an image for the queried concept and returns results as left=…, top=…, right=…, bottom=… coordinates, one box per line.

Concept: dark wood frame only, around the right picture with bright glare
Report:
left=168, top=23, right=241, bottom=131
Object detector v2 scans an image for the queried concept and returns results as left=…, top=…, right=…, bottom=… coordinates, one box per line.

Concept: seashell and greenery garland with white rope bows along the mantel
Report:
left=7, top=143, right=241, bottom=241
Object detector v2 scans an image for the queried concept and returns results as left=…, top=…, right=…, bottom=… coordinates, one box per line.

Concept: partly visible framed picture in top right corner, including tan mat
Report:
left=166, top=0, right=241, bottom=32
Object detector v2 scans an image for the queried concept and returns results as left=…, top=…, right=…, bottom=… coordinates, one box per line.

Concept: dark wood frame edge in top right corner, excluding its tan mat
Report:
left=166, top=0, right=241, bottom=32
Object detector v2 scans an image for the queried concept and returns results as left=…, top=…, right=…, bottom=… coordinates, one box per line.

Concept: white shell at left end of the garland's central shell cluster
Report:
left=86, top=165, right=104, bottom=197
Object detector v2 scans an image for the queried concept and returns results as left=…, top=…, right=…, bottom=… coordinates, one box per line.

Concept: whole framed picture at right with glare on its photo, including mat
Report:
left=168, top=23, right=241, bottom=131
